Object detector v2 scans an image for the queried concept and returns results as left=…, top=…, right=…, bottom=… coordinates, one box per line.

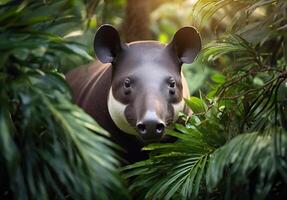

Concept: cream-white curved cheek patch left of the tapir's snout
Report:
left=108, top=87, right=137, bottom=135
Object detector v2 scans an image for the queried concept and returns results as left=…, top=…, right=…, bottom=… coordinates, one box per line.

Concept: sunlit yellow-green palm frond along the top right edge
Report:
left=192, top=0, right=280, bottom=32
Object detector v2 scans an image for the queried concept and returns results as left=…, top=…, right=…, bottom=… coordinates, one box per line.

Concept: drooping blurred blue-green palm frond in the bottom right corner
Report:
left=206, top=129, right=287, bottom=199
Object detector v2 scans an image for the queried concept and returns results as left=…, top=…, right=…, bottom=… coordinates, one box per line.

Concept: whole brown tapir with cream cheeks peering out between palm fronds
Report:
left=66, top=25, right=201, bottom=162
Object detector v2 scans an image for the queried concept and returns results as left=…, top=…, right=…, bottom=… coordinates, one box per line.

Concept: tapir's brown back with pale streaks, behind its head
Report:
left=66, top=62, right=111, bottom=124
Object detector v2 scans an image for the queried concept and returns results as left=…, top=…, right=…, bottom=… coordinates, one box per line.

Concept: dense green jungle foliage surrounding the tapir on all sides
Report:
left=0, top=0, right=287, bottom=200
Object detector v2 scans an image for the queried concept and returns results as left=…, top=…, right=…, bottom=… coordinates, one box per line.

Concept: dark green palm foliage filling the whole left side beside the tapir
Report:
left=0, top=0, right=126, bottom=199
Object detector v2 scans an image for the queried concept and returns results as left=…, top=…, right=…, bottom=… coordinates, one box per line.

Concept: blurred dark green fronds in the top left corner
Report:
left=0, top=0, right=92, bottom=69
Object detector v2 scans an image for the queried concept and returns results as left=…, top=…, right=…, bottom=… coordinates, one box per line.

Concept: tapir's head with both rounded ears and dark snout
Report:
left=94, top=25, right=201, bottom=143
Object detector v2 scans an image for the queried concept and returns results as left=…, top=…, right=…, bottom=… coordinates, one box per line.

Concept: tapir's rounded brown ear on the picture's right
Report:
left=168, top=26, right=201, bottom=63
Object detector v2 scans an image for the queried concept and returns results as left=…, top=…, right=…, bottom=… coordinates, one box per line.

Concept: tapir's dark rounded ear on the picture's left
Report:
left=94, top=24, right=122, bottom=63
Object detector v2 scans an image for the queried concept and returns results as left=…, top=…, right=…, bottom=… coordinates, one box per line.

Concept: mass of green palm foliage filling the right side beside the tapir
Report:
left=124, top=0, right=287, bottom=199
